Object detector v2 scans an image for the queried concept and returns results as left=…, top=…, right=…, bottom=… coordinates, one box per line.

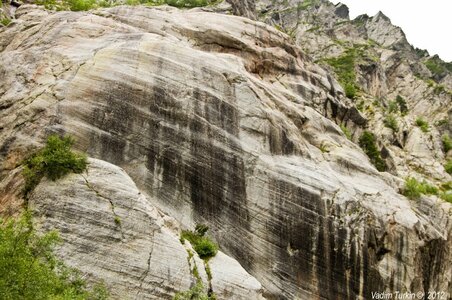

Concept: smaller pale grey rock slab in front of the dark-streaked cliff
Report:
left=29, top=160, right=263, bottom=300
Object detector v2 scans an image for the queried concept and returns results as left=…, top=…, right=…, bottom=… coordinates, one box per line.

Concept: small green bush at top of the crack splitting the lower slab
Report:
left=181, top=225, right=218, bottom=259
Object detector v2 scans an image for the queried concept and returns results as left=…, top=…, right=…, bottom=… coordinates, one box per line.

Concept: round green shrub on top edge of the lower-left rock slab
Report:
left=23, top=135, right=87, bottom=197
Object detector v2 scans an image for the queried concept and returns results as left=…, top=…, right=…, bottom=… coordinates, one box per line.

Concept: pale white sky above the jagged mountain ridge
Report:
left=332, top=0, right=452, bottom=62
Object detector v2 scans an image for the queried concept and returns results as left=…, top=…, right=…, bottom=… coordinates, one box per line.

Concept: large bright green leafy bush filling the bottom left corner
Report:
left=0, top=212, right=108, bottom=300
